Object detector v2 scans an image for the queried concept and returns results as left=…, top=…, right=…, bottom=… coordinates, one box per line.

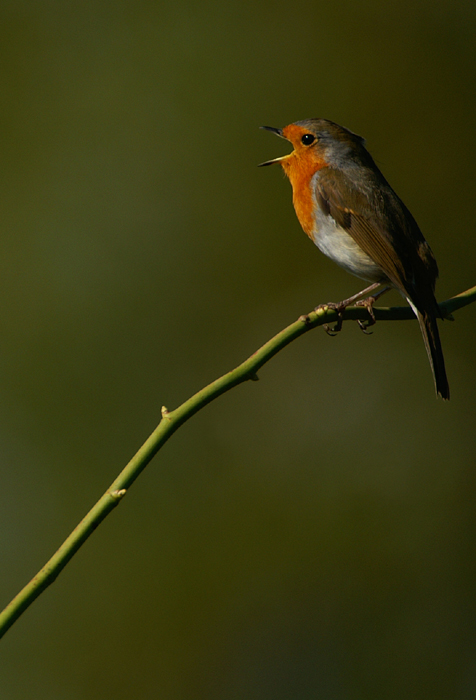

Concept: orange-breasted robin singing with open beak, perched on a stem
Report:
left=261, top=119, right=450, bottom=399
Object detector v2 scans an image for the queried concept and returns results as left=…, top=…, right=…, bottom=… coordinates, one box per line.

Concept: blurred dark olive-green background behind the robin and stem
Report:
left=0, top=0, right=476, bottom=700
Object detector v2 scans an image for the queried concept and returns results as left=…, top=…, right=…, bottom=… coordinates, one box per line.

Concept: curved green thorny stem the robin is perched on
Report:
left=0, top=287, right=476, bottom=637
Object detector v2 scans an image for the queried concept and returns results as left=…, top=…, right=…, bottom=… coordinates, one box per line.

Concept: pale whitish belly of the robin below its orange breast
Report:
left=312, top=207, right=386, bottom=282
